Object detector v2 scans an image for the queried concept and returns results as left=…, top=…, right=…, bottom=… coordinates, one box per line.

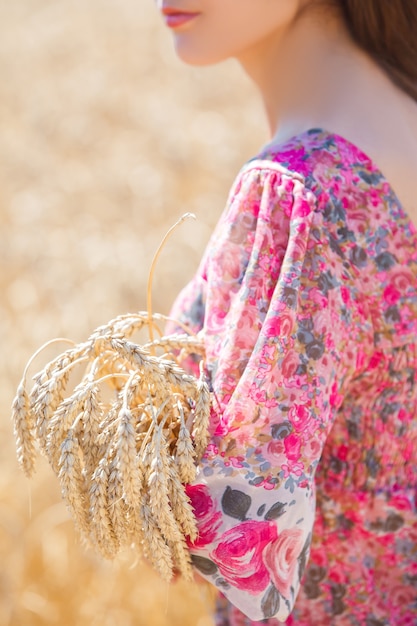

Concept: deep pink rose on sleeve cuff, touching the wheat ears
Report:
left=185, top=485, right=222, bottom=548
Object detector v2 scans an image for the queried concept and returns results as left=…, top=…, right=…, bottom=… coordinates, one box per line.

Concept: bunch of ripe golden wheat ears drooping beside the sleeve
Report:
left=13, top=213, right=210, bottom=580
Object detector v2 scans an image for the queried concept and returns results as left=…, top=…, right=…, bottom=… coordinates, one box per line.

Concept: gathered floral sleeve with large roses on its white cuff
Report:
left=172, top=161, right=359, bottom=621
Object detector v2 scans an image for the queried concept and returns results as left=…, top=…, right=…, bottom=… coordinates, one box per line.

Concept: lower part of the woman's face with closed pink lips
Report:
left=156, top=0, right=309, bottom=65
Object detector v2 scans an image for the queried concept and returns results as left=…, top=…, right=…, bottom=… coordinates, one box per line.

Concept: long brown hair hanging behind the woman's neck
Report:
left=333, top=0, right=417, bottom=101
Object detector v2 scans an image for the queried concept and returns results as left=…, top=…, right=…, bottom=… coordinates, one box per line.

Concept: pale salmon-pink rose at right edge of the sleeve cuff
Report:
left=263, top=528, right=303, bottom=598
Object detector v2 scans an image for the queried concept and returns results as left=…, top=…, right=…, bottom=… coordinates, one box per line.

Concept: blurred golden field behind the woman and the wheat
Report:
left=0, top=0, right=266, bottom=626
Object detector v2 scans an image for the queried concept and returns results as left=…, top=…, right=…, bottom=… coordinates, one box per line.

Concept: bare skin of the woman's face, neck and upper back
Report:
left=156, top=0, right=417, bottom=223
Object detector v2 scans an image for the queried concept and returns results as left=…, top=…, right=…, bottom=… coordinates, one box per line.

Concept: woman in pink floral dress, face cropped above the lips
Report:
left=159, top=0, right=417, bottom=626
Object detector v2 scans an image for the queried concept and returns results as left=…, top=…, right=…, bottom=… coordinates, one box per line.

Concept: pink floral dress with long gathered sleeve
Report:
left=167, top=129, right=417, bottom=626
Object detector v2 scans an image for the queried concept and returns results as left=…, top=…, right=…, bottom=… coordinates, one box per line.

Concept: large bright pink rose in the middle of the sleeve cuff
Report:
left=210, top=520, right=277, bottom=594
